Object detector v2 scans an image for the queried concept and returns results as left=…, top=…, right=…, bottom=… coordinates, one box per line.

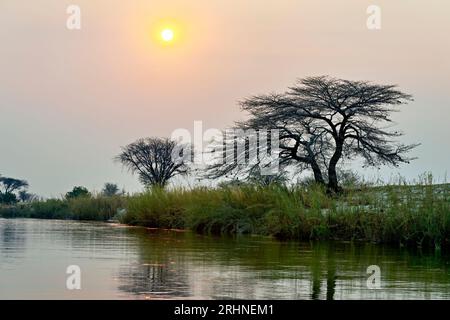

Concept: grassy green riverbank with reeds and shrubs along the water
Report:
left=0, top=184, right=450, bottom=249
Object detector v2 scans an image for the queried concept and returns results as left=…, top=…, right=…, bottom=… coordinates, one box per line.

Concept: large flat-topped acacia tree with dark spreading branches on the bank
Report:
left=212, top=76, right=416, bottom=192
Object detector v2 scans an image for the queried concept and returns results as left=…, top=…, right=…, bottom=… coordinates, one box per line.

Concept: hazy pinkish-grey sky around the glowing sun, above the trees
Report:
left=0, top=0, right=450, bottom=196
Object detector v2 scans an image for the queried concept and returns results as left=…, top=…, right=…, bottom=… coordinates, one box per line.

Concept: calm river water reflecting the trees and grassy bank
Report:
left=0, top=219, right=450, bottom=299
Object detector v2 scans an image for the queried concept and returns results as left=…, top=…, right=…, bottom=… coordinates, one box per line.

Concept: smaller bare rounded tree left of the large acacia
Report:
left=115, top=138, right=189, bottom=187
